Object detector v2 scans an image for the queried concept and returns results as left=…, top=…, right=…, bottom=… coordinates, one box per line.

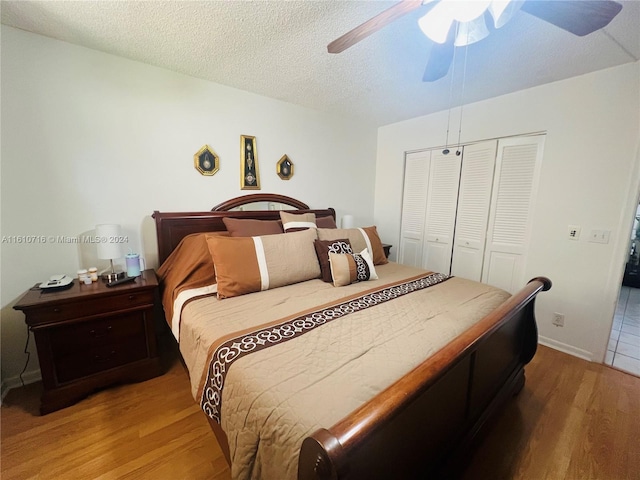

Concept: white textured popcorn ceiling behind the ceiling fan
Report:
left=1, top=0, right=640, bottom=125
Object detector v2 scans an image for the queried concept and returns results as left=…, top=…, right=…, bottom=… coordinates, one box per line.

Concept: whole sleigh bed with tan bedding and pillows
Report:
left=153, top=194, right=551, bottom=480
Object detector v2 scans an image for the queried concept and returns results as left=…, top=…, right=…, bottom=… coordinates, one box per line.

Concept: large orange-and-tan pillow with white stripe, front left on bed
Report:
left=207, top=228, right=320, bottom=298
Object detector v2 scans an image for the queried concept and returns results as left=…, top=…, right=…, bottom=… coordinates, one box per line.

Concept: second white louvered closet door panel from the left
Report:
left=422, top=150, right=462, bottom=274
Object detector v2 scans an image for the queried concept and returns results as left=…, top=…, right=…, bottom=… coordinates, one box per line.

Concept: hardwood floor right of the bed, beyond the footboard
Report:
left=462, top=346, right=640, bottom=480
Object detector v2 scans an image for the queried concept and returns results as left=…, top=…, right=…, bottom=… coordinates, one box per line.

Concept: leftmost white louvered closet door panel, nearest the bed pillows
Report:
left=398, top=151, right=431, bottom=267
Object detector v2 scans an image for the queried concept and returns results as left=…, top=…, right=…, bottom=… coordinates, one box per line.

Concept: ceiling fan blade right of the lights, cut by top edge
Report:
left=521, top=0, right=622, bottom=37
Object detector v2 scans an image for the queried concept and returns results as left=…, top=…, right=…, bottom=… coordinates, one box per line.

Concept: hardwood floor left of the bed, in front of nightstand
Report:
left=0, top=344, right=231, bottom=480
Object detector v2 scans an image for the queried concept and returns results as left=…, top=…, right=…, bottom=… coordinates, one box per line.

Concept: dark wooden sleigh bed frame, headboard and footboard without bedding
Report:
left=153, top=194, right=551, bottom=480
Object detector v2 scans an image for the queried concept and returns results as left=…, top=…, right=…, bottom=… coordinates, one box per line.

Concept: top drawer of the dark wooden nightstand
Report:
left=28, top=291, right=153, bottom=325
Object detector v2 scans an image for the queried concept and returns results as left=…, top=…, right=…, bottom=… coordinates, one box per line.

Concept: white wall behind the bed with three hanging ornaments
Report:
left=1, top=25, right=376, bottom=392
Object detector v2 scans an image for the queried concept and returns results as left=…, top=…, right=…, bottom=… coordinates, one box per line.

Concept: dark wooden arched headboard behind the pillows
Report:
left=152, top=193, right=336, bottom=265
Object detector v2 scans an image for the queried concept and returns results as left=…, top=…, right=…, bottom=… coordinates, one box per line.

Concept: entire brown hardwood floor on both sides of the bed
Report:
left=0, top=346, right=640, bottom=480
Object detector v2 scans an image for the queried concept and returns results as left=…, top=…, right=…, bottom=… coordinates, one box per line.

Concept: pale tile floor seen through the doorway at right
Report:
left=604, top=286, right=640, bottom=376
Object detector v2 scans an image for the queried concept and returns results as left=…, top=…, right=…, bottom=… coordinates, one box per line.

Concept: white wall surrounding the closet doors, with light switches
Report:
left=374, top=62, right=640, bottom=361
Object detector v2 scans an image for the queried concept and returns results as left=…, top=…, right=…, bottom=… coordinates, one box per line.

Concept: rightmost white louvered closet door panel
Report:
left=482, top=136, right=544, bottom=292
